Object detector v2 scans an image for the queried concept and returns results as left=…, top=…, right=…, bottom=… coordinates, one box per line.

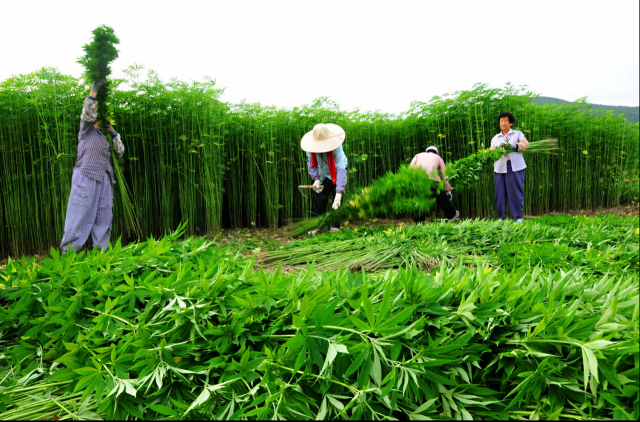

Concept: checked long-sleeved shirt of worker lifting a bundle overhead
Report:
left=75, top=97, right=124, bottom=183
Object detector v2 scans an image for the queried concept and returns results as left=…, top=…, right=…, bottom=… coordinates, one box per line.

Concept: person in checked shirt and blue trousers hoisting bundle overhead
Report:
left=60, top=78, right=124, bottom=253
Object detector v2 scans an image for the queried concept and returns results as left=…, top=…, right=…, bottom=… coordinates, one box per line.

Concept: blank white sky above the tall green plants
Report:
left=0, top=0, right=640, bottom=113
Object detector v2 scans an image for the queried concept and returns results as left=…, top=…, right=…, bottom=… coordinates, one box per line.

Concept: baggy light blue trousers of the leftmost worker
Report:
left=60, top=169, right=113, bottom=252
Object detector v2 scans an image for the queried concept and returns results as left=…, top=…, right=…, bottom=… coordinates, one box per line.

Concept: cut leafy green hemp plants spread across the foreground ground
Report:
left=0, top=216, right=640, bottom=420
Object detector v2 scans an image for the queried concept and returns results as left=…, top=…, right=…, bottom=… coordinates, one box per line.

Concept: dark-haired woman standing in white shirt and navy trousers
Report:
left=491, top=111, right=529, bottom=223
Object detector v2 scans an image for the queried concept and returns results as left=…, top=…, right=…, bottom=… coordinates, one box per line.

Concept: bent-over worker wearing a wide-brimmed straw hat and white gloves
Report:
left=300, top=123, right=347, bottom=234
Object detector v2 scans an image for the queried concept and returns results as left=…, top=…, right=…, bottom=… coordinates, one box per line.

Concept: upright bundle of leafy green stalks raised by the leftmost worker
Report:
left=78, top=25, right=142, bottom=238
